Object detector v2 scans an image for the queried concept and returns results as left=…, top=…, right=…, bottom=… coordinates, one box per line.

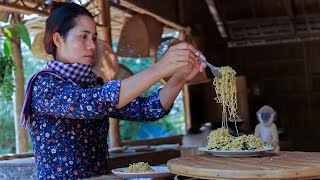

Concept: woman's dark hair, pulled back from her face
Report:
left=43, top=2, right=93, bottom=58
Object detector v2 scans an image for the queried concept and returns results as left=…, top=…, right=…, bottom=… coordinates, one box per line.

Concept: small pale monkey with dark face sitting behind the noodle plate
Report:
left=254, top=105, right=280, bottom=153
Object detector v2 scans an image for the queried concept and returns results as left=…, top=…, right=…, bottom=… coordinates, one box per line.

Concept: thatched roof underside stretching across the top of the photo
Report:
left=0, top=0, right=320, bottom=47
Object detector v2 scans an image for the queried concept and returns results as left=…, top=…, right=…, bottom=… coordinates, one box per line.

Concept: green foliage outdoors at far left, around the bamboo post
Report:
left=0, top=22, right=44, bottom=154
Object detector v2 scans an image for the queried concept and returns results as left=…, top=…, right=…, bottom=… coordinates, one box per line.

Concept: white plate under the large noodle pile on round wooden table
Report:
left=199, top=147, right=273, bottom=157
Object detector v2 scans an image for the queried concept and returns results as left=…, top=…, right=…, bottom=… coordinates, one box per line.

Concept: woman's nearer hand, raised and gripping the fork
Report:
left=155, top=42, right=198, bottom=78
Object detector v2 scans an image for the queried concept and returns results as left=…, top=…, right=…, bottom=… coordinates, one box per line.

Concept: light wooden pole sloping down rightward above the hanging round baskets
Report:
left=111, top=0, right=187, bottom=31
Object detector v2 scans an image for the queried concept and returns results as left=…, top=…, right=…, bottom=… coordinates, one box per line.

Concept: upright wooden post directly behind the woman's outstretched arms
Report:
left=99, top=0, right=121, bottom=148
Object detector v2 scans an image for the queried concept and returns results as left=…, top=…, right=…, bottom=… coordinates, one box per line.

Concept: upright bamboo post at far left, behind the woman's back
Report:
left=10, top=27, right=28, bottom=153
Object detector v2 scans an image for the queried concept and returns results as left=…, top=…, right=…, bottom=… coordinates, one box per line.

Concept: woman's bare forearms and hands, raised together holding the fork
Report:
left=117, top=43, right=205, bottom=110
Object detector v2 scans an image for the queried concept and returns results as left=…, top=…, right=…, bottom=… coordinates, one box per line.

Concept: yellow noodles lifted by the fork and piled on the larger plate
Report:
left=207, top=66, right=271, bottom=150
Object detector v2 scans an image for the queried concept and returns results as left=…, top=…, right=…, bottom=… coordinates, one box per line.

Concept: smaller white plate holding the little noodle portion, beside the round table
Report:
left=111, top=166, right=172, bottom=178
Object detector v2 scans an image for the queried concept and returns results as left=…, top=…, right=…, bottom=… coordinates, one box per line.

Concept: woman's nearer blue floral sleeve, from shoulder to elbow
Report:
left=32, top=74, right=120, bottom=119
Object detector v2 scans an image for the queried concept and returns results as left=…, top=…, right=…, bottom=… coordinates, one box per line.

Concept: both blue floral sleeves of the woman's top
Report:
left=32, top=74, right=166, bottom=121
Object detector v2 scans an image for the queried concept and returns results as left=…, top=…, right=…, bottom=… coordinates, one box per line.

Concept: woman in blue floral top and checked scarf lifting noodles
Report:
left=21, top=3, right=205, bottom=179
